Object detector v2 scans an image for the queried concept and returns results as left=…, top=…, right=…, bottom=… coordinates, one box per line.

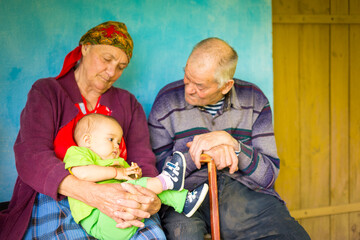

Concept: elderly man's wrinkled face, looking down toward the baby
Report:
left=184, top=59, right=226, bottom=106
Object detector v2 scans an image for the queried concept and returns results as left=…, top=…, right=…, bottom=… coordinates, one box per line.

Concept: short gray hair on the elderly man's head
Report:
left=190, top=37, right=238, bottom=88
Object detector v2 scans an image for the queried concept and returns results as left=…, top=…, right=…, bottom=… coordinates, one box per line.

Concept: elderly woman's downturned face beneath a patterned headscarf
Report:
left=77, top=45, right=128, bottom=94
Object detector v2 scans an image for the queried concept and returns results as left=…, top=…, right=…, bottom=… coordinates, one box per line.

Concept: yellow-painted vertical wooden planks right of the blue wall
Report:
left=272, top=0, right=360, bottom=240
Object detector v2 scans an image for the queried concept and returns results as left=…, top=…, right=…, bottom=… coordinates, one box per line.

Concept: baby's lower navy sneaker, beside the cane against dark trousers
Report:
left=183, top=183, right=209, bottom=217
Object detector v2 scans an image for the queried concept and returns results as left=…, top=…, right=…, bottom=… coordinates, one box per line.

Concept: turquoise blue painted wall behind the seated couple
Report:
left=0, top=0, right=273, bottom=201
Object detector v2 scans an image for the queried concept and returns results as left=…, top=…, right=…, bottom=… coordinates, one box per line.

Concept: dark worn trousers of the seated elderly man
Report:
left=161, top=173, right=310, bottom=240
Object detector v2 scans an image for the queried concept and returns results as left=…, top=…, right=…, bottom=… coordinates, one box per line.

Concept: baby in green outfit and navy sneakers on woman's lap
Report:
left=64, top=114, right=209, bottom=239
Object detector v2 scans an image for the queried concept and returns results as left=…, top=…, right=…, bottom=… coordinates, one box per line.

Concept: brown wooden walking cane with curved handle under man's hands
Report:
left=200, top=154, right=220, bottom=240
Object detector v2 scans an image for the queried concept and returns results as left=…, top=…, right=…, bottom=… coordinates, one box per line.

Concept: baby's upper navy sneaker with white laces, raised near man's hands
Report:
left=162, top=151, right=186, bottom=191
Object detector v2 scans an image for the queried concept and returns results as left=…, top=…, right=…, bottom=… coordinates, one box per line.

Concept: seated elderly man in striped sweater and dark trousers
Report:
left=148, top=38, right=310, bottom=239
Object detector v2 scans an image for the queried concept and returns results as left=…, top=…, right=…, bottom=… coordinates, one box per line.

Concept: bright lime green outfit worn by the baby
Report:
left=64, top=146, right=188, bottom=240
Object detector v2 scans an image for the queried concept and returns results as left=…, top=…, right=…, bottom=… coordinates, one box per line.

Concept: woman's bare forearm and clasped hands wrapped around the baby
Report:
left=58, top=175, right=161, bottom=228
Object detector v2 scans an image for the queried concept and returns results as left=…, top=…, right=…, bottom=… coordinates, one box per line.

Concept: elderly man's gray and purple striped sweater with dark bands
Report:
left=148, top=79, right=280, bottom=199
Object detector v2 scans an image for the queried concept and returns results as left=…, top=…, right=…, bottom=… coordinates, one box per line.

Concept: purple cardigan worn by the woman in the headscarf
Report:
left=0, top=70, right=158, bottom=239
